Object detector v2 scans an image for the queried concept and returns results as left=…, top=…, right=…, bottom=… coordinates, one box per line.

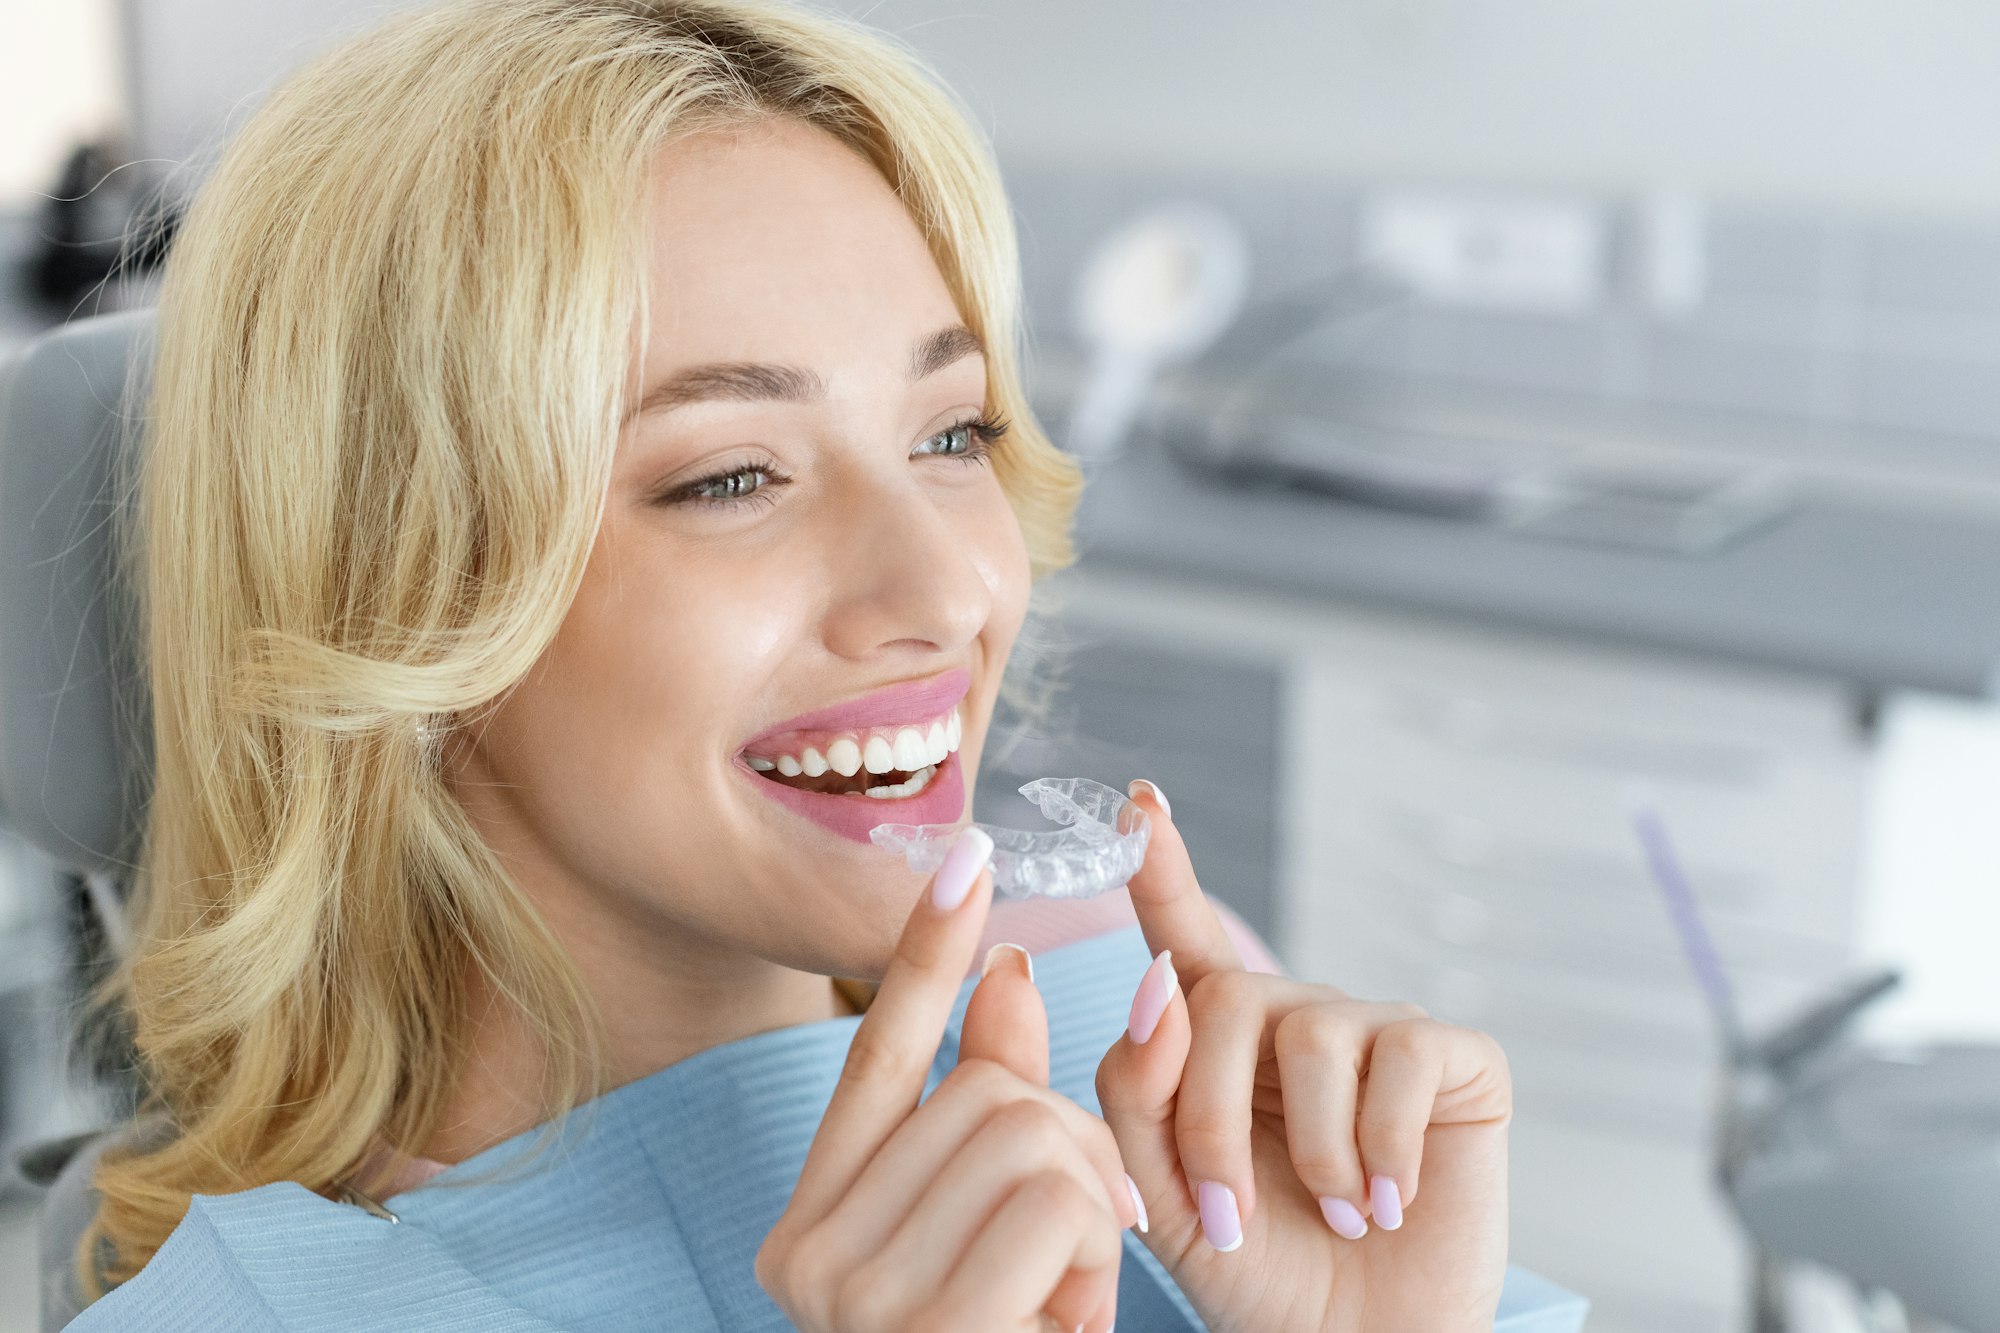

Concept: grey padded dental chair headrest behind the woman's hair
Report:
left=0, top=310, right=154, bottom=881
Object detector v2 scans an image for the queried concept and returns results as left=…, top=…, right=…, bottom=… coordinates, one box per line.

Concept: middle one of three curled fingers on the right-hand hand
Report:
left=1272, top=999, right=1424, bottom=1241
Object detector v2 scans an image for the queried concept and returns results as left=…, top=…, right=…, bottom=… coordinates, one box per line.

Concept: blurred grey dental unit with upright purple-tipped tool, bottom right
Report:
left=1626, top=789, right=2000, bottom=1333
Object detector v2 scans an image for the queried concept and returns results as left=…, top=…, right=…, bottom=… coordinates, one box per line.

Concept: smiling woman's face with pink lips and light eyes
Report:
left=456, top=120, right=1028, bottom=977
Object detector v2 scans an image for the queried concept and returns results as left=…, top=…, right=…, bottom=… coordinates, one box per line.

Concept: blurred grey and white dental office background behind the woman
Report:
left=0, top=0, right=2000, bottom=1333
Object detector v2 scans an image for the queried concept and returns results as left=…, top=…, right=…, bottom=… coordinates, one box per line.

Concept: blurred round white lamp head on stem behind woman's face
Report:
left=1064, top=204, right=1250, bottom=460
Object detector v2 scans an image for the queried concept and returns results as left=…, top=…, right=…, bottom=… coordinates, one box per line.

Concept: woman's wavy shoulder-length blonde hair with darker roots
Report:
left=76, top=0, right=1082, bottom=1297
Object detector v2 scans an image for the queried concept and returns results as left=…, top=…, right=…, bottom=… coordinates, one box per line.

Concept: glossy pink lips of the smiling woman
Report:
left=736, top=669, right=972, bottom=843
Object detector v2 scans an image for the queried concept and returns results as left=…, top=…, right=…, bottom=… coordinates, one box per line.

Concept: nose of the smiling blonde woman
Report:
left=822, top=466, right=996, bottom=660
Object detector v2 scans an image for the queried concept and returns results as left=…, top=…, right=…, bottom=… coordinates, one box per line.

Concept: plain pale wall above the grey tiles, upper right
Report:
left=832, top=0, right=2000, bottom=218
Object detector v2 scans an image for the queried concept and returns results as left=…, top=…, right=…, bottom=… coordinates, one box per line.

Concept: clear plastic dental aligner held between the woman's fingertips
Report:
left=868, top=779, right=1152, bottom=899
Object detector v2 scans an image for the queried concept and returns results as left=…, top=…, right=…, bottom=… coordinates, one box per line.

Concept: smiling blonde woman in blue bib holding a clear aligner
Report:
left=62, top=0, right=1568, bottom=1333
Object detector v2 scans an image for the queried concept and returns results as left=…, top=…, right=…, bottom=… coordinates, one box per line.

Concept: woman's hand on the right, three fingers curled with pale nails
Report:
left=1098, top=783, right=1512, bottom=1333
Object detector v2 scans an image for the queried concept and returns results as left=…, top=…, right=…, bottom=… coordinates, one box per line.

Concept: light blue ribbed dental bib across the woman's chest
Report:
left=68, top=927, right=1586, bottom=1333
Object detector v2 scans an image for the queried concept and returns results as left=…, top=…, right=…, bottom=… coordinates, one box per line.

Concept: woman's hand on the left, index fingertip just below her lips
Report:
left=756, top=831, right=1138, bottom=1333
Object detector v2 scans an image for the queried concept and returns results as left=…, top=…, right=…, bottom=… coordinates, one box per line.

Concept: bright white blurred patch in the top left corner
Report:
left=0, top=0, right=124, bottom=208
